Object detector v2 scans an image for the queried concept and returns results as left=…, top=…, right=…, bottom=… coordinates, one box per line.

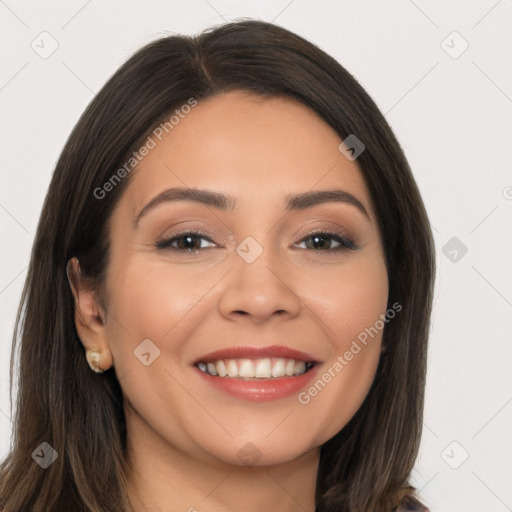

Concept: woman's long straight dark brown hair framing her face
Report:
left=0, top=20, right=435, bottom=512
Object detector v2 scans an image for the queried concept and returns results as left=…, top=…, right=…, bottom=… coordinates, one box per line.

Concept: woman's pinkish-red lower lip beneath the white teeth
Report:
left=194, top=364, right=318, bottom=402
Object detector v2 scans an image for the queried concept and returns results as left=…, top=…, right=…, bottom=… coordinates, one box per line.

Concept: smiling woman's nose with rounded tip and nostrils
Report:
left=219, top=240, right=302, bottom=324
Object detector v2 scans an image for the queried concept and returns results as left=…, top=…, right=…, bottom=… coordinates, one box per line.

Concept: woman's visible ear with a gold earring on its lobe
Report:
left=66, top=258, right=113, bottom=373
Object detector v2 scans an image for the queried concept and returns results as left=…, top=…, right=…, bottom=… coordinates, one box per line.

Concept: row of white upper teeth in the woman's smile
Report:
left=197, top=357, right=311, bottom=379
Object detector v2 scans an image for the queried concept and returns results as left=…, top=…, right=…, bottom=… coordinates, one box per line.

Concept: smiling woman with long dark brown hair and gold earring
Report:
left=0, top=20, right=435, bottom=512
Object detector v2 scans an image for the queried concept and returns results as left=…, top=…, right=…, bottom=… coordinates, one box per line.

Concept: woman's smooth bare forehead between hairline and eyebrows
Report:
left=121, top=91, right=373, bottom=217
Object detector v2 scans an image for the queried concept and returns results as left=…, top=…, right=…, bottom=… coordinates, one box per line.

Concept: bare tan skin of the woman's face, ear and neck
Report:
left=71, top=91, right=388, bottom=512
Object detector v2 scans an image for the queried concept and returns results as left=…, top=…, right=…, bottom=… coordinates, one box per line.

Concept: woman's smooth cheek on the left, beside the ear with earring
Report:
left=101, top=258, right=211, bottom=442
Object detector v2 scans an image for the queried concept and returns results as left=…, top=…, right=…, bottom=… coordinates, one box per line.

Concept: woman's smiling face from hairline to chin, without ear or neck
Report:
left=96, top=92, right=388, bottom=465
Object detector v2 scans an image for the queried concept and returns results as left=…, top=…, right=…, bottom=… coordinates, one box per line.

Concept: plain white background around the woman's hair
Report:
left=0, top=0, right=512, bottom=512
